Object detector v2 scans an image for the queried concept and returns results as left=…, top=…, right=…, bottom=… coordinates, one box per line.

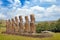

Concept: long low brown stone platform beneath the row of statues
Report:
left=2, top=32, right=53, bottom=38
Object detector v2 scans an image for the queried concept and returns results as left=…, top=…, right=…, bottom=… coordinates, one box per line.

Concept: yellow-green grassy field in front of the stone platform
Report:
left=0, top=28, right=60, bottom=40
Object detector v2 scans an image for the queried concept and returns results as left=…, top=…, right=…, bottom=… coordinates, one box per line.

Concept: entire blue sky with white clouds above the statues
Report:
left=0, top=0, right=60, bottom=21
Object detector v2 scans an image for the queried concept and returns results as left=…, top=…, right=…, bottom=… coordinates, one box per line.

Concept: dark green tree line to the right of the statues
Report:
left=36, top=19, right=60, bottom=33
